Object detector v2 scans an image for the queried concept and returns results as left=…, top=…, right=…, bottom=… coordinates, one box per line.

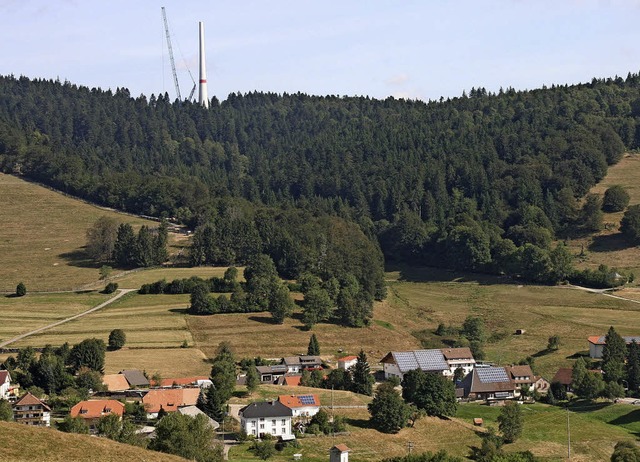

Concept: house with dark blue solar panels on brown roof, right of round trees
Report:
left=459, top=366, right=517, bottom=401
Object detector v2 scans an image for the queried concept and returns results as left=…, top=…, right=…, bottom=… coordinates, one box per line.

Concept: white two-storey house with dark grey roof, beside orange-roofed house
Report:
left=239, top=401, right=294, bottom=440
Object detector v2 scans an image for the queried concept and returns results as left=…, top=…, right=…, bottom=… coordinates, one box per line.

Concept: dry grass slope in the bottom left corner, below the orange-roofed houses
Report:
left=0, top=422, right=186, bottom=462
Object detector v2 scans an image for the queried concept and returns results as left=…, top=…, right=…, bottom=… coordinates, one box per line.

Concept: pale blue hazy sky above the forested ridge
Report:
left=0, top=0, right=640, bottom=100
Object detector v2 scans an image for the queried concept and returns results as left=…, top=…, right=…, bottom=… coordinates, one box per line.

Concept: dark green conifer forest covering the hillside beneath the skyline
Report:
left=0, top=74, right=640, bottom=287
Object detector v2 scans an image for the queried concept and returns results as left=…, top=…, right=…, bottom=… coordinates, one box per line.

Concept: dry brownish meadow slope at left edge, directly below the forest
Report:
left=0, top=173, right=157, bottom=292
